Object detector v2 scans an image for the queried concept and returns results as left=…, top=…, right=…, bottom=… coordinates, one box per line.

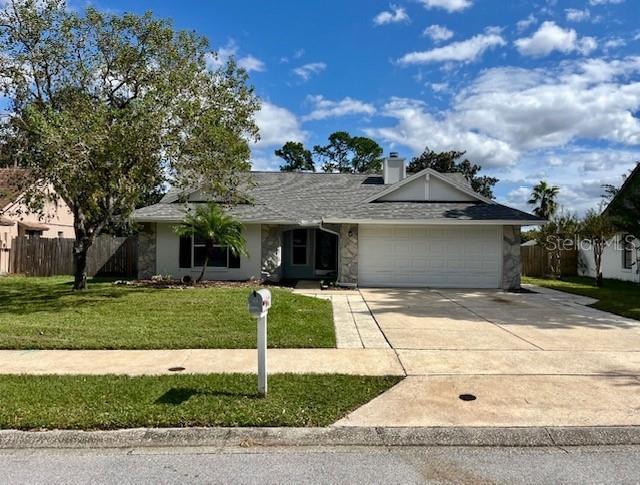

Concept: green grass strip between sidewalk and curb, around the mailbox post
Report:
left=0, top=374, right=401, bottom=430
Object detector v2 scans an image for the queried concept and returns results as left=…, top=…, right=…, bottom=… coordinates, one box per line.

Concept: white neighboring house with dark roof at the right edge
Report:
left=578, top=163, right=640, bottom=283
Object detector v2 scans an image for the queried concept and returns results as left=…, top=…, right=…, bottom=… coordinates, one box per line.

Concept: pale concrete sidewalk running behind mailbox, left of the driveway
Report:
left=0, top=349, right=404, bottom=376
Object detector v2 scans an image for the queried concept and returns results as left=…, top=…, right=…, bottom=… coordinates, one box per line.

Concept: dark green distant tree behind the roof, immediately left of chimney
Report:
left=313, top=131, right=382, bottom=173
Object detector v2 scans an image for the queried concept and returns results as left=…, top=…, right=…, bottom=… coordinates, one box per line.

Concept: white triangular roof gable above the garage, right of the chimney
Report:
left=365, top=168, right=494, bottom=204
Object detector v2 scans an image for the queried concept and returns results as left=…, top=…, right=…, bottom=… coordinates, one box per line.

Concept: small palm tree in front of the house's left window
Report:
left=174, top=203, right=248, bottom=283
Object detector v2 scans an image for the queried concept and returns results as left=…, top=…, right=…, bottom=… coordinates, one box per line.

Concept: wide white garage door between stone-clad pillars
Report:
left=358, top=225, right=502, bottom=288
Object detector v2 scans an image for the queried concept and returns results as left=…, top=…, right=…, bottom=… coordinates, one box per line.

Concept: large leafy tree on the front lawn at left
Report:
left=0, top=0, right=259, bottom=289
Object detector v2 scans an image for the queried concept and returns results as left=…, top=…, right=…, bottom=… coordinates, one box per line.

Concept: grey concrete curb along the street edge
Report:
left=0, top=426, right=640, bottom=449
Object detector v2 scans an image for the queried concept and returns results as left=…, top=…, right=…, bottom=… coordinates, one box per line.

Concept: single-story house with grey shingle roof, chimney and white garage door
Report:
left=133, top=154, right=544, bottom=288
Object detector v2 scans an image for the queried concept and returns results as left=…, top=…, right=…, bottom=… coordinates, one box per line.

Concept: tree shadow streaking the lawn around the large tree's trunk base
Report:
left=0, top=277, right=153, bottom=318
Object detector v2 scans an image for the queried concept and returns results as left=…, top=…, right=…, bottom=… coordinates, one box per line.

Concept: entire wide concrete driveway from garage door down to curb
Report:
left=338, top=288, right=640, bottom=426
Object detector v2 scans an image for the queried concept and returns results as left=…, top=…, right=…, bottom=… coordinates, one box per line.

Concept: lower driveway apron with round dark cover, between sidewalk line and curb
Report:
left=336, top=375, right=640, bottom=427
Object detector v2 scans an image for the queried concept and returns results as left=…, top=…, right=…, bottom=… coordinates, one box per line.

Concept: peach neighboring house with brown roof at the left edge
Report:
left=0, top=168, right=74, bottom=274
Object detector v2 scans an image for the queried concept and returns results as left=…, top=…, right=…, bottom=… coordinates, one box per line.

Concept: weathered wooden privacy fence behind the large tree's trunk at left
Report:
left=9, top=236, right=138, bottom=277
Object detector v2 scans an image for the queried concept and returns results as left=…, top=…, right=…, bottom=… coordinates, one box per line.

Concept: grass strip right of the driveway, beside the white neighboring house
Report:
left=522, top=276, right=640, bottom=320
